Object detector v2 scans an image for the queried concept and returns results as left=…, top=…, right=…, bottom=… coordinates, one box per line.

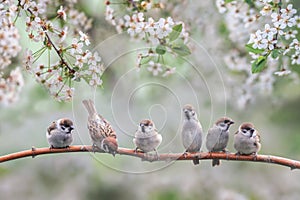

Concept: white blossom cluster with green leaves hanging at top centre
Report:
left=105, top=1, right=191, bottom=77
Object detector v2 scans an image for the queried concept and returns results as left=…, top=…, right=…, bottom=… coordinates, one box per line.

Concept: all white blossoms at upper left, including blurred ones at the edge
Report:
left=0, top=0, right=104, bottom=103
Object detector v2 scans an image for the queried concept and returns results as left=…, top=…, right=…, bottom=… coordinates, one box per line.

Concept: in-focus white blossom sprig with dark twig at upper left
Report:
left=13, top=1, right=103, bottom=101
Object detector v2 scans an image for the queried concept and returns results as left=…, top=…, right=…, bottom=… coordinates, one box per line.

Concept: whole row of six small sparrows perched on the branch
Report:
left=46, top=100, right=261, bottom=166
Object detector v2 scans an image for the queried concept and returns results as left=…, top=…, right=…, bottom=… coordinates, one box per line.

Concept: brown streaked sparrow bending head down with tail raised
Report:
left=82, top=99, right=118, bottom=156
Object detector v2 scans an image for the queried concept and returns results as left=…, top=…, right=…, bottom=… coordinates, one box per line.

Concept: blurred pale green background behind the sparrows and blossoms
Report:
left=0, top=1, right=300, bottom=200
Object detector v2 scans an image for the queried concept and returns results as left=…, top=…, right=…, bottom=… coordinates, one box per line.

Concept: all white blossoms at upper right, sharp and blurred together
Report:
left=216, top=0, right=300, bottom=108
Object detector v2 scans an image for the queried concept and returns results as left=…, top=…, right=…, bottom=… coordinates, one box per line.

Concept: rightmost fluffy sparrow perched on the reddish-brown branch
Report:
left=234, top=122, right=261, bottom=156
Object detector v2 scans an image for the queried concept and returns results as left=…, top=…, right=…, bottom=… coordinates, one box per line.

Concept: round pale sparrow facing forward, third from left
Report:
left=133, top=119, right=162, bottom=156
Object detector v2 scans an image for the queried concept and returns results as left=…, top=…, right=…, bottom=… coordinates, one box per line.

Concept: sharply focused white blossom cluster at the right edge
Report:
left=248, top=1, right=300, bottom=74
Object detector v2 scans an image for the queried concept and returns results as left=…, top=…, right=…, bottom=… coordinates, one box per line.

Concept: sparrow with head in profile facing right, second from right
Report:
left=206, top=117, right=234, bottom=167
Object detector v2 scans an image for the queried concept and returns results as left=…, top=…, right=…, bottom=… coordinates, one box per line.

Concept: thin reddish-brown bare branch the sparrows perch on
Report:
left=0, top=145, right=300, bottom=169
